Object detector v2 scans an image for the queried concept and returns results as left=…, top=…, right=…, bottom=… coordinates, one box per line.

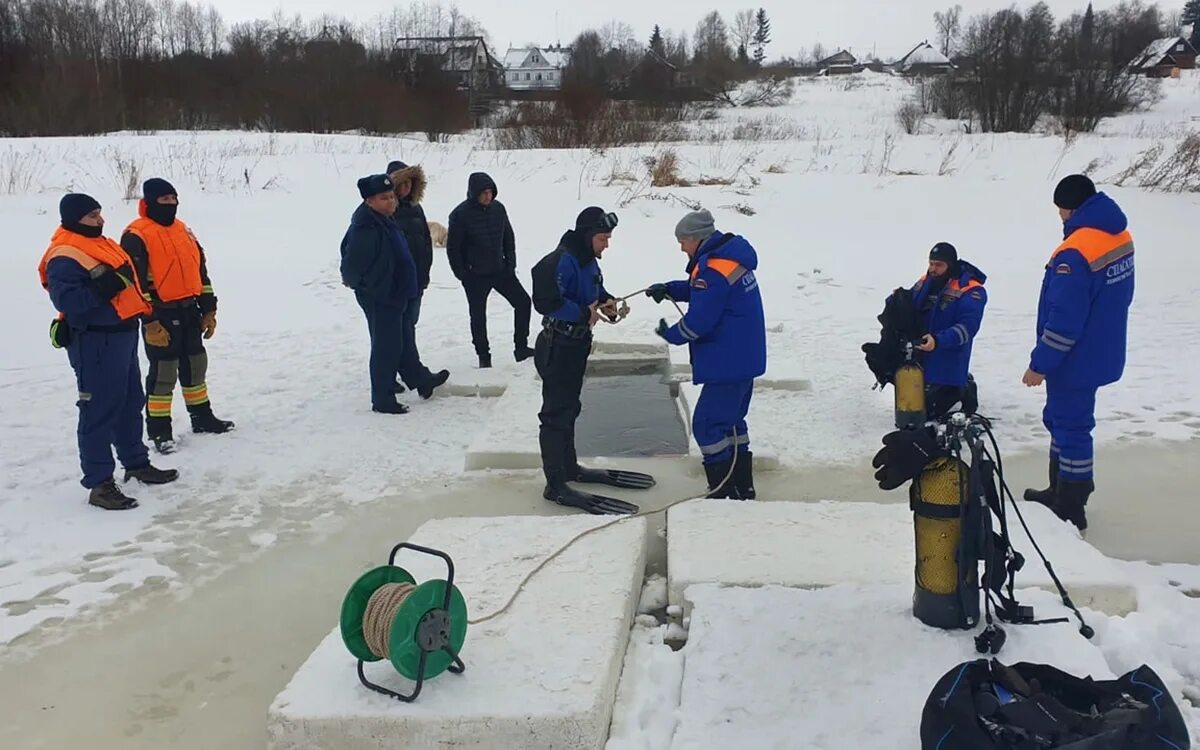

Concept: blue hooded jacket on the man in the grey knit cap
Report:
left=665, top=233, right=767, bottom=384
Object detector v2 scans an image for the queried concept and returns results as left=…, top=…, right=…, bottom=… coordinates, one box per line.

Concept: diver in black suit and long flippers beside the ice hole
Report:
left=533, top=206, right=654, bottom=514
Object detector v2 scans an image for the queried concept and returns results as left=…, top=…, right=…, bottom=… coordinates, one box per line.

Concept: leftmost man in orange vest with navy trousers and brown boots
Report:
left=37, top=193, right=179, bottom=510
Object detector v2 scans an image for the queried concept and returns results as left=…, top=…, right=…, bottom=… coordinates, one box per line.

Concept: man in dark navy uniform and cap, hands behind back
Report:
left=341, top=174, right=419, bottom=414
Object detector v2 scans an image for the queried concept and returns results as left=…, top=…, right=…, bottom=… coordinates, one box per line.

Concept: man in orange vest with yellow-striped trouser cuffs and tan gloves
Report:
left=121, top=178, right=234, bottom=454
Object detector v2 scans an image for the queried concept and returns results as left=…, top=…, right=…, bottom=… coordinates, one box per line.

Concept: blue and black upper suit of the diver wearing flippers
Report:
left=532, top=229, right=612, bottom=323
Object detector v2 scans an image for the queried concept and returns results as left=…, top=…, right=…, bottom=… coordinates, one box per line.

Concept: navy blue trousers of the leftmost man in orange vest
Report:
left=67, top=329, right=150, bottom=490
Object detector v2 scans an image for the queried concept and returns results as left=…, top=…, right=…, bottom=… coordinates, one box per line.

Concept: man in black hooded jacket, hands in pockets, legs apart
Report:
left=446, top=172, right=533, bottom=367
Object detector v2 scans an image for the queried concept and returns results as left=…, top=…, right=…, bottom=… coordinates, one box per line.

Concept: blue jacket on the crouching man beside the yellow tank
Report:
left=912, top=260, right=988, bottom=385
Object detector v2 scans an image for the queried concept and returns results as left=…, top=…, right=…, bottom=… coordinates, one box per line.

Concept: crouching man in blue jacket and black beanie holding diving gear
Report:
left=912, top=242, right=988, bottom=418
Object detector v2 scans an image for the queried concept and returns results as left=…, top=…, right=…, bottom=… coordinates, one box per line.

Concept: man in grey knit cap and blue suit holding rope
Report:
left=646, top=211, right=767, bottom=499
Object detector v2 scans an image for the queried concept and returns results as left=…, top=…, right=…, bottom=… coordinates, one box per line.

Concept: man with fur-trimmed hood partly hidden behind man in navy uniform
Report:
left=388, top=162, right=450, bottom=398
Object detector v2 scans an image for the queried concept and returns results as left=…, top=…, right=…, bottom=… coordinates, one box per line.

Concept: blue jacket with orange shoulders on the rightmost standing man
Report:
left=1030, top=193, right=1134, bottom=388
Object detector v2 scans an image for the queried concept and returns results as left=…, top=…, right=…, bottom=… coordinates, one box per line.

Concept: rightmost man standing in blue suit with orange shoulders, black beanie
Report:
left=1022, top=174, right=1134, bottom=530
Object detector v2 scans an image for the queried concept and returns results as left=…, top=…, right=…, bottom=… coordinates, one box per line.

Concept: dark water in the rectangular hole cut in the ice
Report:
left=575, top=374, right=688, bottom=457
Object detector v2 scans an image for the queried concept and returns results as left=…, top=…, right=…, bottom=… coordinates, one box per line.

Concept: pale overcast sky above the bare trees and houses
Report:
left=202, top=0, right=1152, bottom=60
